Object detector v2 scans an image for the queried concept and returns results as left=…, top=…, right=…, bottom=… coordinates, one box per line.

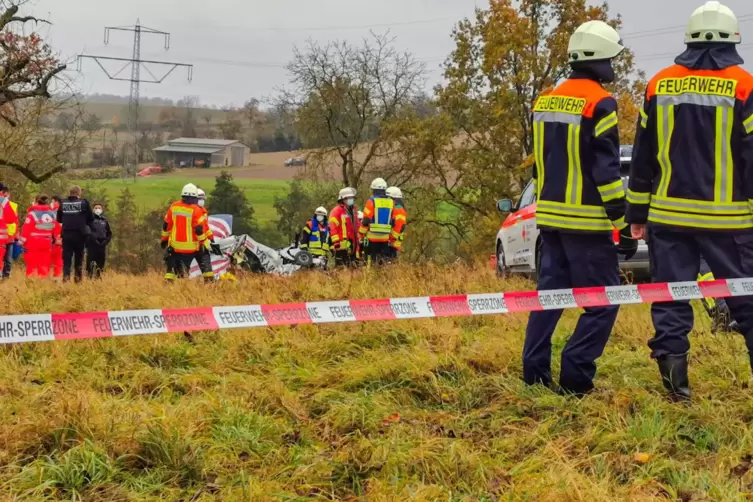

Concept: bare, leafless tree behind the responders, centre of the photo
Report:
left=276, top=33, right=426, bottom=186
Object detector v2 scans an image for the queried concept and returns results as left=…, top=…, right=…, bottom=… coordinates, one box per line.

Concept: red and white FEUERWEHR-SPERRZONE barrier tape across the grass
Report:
left=0, top=278, right=753, bottom=344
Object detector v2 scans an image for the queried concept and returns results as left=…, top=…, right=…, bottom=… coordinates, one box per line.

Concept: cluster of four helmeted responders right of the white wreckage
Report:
left=300, top=178, right=407, bottom=266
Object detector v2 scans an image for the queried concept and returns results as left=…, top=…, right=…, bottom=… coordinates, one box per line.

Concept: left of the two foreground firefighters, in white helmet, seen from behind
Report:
left=523, top=21, right=637, bottom=395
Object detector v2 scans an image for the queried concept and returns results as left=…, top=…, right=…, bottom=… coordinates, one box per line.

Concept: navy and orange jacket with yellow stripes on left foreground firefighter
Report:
left=533, top=73, right=626, bottom=232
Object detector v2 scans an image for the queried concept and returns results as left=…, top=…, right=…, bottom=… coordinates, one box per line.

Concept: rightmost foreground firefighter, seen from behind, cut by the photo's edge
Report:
left=627, top=2, right=753, bottom=400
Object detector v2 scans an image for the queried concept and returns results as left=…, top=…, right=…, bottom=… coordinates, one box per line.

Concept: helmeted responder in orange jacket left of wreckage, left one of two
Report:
left=161, top=183, right=205, bottom=280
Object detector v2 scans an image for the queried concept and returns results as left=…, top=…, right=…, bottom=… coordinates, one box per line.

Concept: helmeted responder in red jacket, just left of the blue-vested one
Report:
left=329, top=187, right=361, bottom=265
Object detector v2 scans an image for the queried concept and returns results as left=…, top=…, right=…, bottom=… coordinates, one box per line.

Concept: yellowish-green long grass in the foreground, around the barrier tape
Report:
left=0, top=265, right=753, bottom=502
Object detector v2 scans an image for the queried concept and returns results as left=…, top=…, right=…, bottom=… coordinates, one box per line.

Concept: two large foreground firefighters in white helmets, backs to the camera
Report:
left=523, top=1, right=753, bottom=401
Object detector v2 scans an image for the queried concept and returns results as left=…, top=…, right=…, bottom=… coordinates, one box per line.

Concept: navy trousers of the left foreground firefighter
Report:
left=523, top=231, right=620, bottom=394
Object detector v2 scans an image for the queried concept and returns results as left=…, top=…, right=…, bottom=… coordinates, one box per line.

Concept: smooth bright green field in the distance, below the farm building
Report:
left=75, top=176, right=288, bottom=223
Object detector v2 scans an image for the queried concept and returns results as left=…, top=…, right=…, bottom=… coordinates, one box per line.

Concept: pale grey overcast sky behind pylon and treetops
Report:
left=27, top=0, right=753, bottom=106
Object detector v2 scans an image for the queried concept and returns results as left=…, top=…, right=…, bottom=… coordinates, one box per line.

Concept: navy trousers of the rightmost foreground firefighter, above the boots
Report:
left=648, top=226, right=753, bottom=359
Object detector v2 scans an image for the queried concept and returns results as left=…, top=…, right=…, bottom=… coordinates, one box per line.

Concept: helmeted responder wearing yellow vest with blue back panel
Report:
left=358, top=178, right=395, bottom=264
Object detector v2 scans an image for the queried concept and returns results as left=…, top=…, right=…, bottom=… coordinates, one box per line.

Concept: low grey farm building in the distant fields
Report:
left=154, top=138, right=249, bottom=167
